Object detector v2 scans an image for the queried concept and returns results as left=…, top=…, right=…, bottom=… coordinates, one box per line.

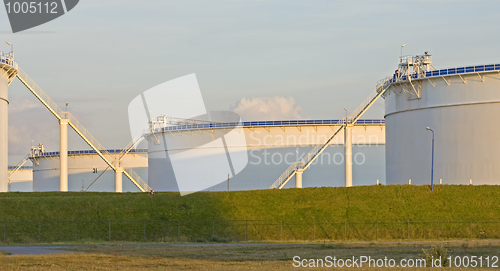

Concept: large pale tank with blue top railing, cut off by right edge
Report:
left=384, top=62, right=500, bottom=184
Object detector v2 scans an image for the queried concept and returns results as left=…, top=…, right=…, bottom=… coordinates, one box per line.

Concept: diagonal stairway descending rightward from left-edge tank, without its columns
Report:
left=16, top=67, right=153, bottom=192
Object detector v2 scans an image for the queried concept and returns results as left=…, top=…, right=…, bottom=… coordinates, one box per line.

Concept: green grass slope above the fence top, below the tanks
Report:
left=0, top=185, right=500, bottom=221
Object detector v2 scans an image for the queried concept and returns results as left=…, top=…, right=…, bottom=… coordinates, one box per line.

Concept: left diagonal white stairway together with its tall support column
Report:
left=15, top=67, right=152, bottom=192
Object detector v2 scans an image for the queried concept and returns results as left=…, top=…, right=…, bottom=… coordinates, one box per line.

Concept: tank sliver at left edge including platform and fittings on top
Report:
left=0, top=52, right=18, bottom=192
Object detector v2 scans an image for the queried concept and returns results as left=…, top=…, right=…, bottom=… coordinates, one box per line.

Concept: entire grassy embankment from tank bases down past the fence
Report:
left=0, top=185, right=500, bottom=243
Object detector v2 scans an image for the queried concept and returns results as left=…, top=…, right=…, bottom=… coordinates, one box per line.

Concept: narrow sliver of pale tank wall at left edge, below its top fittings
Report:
left=0, top=74, right=9, bottom=192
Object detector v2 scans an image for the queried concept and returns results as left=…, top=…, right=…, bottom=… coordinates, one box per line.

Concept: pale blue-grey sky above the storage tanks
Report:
left=0, top=0, right=500, bottom=165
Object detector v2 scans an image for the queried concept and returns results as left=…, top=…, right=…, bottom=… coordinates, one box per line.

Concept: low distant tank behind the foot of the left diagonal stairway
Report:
left=30, top=149, right=148, bottom=192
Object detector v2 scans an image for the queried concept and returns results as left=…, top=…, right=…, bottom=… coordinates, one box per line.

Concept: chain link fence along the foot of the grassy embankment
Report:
left=0, top=219, right=500, bottom=244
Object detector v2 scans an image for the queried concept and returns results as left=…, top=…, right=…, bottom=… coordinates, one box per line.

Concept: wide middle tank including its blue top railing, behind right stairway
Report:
left=146, top=120, right=385, bottom=191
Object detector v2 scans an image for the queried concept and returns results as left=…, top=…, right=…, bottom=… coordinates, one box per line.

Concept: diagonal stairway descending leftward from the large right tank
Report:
left=269, top=77, right=391, bottom=189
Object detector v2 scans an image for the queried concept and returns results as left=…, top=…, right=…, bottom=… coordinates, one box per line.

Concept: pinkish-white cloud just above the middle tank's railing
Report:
left=233, top=96, right=302, bottom=121
